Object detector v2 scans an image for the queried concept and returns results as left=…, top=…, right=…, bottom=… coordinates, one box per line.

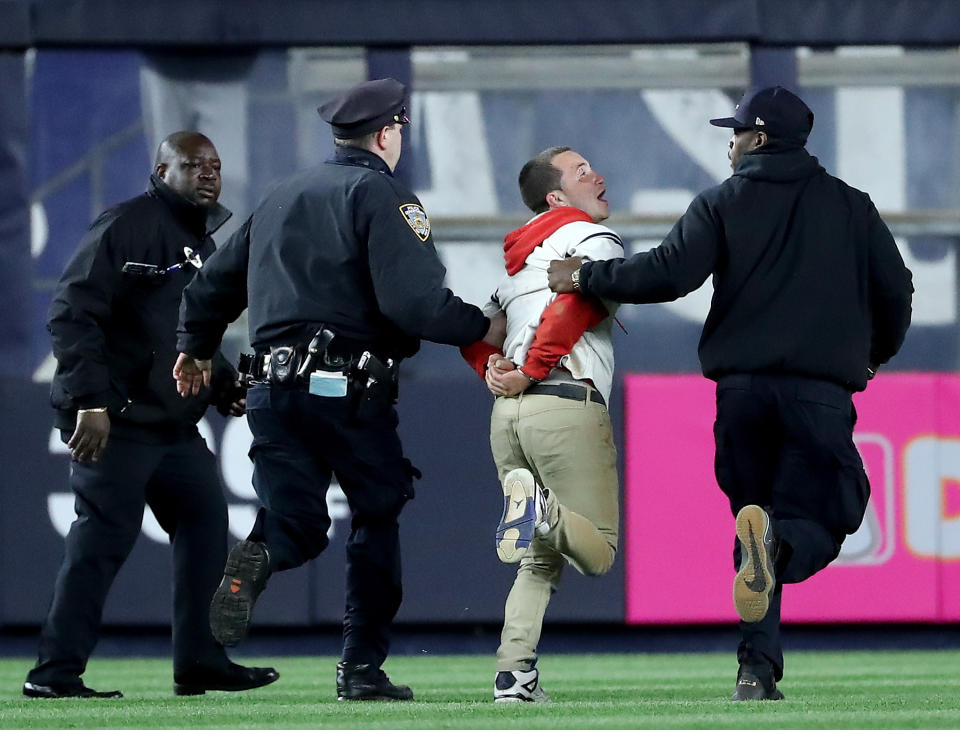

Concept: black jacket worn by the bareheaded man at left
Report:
left=47, top=175, right=235, bottom=441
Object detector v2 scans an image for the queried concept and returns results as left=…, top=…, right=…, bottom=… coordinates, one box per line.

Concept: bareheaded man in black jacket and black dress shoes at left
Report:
left=23, top=132, right=278, bottom=698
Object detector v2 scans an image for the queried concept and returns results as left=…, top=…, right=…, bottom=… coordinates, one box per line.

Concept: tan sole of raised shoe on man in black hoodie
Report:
left=733, top=505, right=775, bottom=623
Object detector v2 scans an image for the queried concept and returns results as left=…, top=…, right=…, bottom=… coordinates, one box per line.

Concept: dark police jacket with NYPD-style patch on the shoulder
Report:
left=177, top=149, right=488, bottom=360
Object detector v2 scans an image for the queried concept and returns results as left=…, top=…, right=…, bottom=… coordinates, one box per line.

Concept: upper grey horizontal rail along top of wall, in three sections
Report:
left=288, top=43, right=960, bottom=93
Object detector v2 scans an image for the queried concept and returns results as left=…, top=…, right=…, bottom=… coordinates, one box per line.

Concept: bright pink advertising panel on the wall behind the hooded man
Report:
left=623, top=373, right=960, bottom=623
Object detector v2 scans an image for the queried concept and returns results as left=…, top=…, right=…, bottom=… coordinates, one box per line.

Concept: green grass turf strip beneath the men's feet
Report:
left=0, top=651, right=960, bottom=730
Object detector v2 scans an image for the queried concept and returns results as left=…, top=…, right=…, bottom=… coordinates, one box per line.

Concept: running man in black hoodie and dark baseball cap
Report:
left=549, top=86, right=913, bottom=700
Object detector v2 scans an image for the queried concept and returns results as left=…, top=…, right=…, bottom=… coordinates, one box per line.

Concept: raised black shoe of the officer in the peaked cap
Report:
left=210, top=540, right=270, bottom=646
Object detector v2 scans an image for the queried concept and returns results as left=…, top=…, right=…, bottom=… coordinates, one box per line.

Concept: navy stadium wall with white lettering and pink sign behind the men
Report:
left=0, top=0, right=960, bottom=626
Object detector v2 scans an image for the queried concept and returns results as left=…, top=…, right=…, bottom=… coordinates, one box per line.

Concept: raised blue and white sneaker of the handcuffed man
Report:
left=496, top=469, right=550, bottom=563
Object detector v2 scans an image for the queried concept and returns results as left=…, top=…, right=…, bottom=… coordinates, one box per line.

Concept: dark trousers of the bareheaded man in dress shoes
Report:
left=27, top=435, right=227, bottom=685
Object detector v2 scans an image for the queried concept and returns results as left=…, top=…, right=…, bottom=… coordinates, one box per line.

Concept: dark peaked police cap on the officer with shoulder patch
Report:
left=317, top=78, right=410, bottom=139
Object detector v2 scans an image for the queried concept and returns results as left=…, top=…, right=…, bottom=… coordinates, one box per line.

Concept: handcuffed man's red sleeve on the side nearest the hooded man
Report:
left=522, top=294, right=610, bottom=380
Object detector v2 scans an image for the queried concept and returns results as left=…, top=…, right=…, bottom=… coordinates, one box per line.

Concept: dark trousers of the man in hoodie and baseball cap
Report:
left=714, top=374, right=870, bottom=679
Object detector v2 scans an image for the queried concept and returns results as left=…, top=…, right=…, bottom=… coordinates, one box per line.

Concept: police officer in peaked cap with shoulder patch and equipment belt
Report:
left=174, top=79, right=502, bottom=700
